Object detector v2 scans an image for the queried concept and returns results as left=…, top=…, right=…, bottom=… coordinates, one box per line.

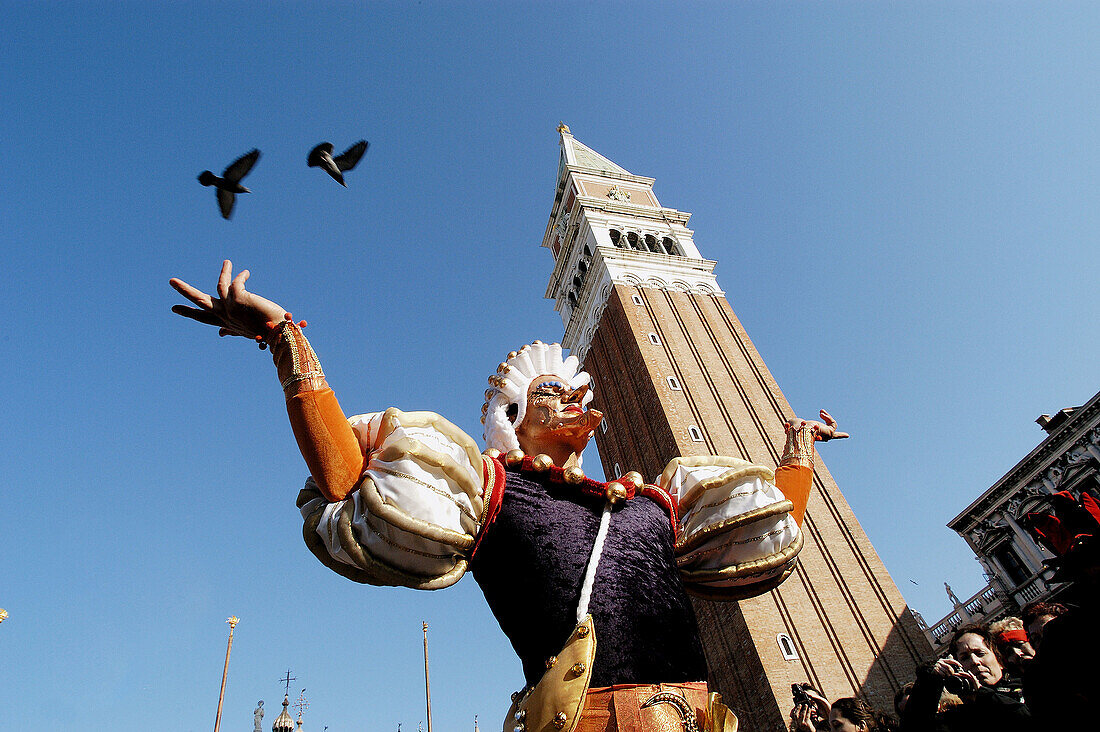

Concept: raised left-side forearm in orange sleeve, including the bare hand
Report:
left=169, top=260, right=363, bottom=501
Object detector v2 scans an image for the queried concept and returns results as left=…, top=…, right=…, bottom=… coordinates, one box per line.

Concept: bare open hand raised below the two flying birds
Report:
left=168, top=260, right=286, bottom=338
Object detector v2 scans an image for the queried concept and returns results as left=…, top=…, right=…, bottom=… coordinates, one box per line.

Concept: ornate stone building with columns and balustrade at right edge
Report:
left=927, top=393, right=1100, bottom=652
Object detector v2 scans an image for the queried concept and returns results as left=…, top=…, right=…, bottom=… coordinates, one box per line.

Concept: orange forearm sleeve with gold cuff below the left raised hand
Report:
left=266, top=320, right=364, bottom=501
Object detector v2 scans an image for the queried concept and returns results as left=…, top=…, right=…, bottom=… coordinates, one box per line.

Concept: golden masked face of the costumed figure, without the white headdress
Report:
left=516, top=374, right=604, bottom=455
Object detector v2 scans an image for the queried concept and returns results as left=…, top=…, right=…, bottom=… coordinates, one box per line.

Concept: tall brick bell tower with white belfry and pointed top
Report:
left=542, top=124, right=932, bottom=732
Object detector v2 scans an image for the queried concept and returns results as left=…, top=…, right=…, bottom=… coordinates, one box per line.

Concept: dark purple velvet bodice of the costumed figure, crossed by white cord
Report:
left=471, top=470, right=706, bottom=687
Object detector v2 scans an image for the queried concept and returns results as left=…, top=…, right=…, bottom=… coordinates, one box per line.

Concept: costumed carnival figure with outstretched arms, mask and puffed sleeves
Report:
left=172, top=261, right=847, bottom=732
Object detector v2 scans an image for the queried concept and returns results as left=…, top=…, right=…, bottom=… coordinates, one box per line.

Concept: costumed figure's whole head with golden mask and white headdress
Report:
left=482, top=340, right=603, bottom=456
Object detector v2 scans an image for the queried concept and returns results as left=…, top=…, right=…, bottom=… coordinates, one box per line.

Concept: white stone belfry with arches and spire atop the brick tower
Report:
left=542, top=124, right=724, bottom=361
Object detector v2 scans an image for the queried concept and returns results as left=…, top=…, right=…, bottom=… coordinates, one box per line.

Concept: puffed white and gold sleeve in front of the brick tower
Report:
left=660, top=456, right=803, bottom=600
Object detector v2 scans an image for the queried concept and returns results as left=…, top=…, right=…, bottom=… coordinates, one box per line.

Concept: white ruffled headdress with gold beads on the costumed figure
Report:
left=482, top=340, right=592, bottom=452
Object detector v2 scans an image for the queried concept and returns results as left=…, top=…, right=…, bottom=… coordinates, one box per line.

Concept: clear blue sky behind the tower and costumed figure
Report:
left=0, top=2, right=1100, bottom=732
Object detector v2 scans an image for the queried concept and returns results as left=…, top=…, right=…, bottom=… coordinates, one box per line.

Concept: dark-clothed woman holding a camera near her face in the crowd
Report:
left=901, top=625, right=1032, bottom=732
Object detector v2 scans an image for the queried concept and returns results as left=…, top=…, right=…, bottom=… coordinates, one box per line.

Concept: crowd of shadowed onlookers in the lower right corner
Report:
left=791, top=479, right=1100, bottom=732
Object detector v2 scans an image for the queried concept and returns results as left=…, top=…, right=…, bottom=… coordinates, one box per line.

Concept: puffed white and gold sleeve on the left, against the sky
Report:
left=298, top=408, right=496, bottom=590
